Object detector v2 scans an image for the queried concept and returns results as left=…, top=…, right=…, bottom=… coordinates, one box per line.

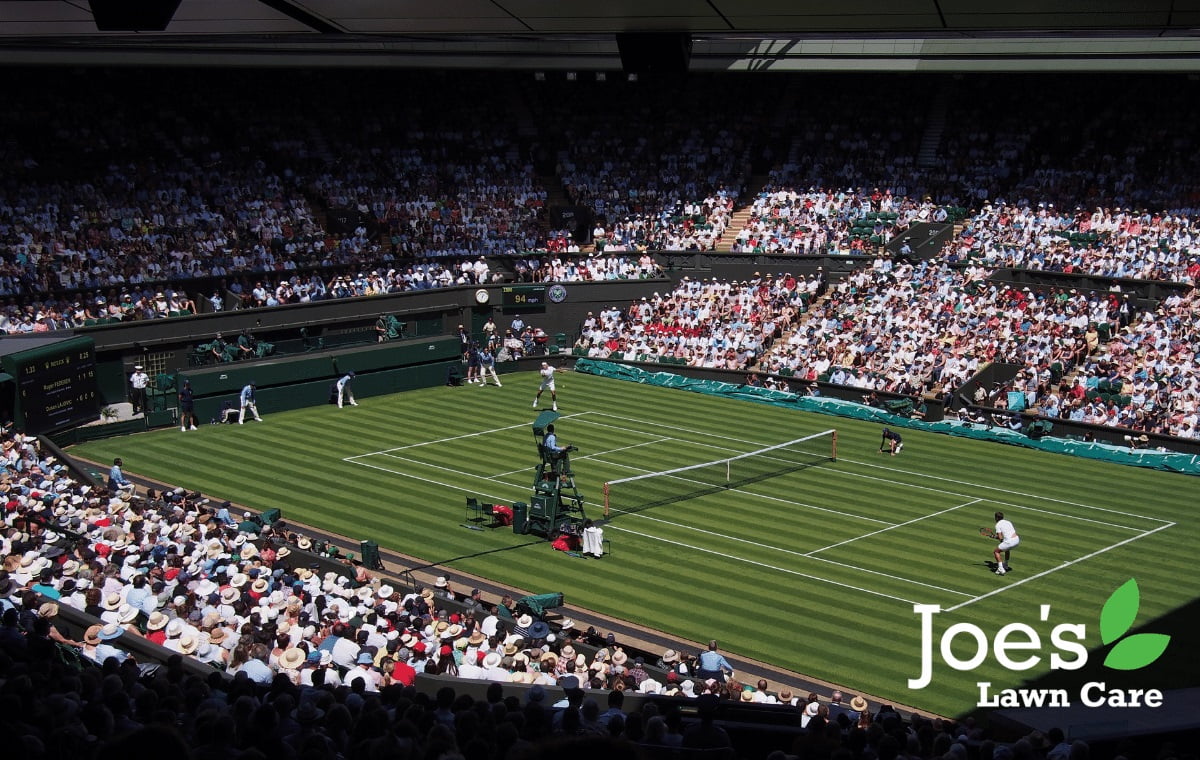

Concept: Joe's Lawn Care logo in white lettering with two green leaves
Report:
left=908, top=578, right=1171, bottom=707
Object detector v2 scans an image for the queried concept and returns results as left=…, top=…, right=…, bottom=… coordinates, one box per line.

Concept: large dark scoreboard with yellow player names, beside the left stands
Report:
left=0, top=337, right=100, bottom=435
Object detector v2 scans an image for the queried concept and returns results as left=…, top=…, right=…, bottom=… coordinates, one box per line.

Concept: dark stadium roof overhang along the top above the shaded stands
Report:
left=0, top=0, right=1200, bottom=71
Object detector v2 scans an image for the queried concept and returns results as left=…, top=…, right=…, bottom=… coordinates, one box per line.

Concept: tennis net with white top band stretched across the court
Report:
left=604, top=429, right=838, bottom=517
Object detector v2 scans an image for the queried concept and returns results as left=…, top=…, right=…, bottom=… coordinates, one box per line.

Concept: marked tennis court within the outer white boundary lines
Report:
left=346, top=412, right=1175, bottom=610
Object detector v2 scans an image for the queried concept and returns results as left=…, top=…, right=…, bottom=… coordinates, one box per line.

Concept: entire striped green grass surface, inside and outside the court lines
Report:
left=72, top=373, right=1200, bottom=714
